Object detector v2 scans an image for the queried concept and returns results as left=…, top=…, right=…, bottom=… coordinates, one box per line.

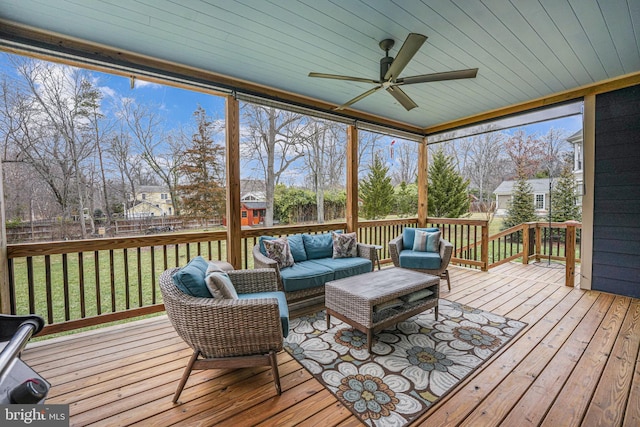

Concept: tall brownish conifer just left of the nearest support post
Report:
left=178, top=106, right=225, bottom=217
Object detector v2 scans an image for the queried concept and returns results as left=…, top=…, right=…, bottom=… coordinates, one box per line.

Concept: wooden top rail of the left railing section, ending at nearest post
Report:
left=7, top=230, right=227, bottom=258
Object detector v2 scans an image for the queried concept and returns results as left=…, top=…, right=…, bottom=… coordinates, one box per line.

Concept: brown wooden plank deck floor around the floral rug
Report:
left=24, top=263, right=640, bottom=427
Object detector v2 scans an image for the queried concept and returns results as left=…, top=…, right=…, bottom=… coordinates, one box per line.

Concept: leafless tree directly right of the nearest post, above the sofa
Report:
left=242, top=103, right=309, bottom=227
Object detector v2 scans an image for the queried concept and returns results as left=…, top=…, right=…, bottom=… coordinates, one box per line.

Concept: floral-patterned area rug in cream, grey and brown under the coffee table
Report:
left=285, top=299, right=526, bottom=426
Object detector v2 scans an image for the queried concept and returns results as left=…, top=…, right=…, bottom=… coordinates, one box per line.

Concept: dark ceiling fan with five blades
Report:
left=309, top=33, right=478, bottom=111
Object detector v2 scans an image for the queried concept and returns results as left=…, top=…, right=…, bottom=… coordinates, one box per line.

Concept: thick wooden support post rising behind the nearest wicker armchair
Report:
left=225, top=96, right=242, bottom=269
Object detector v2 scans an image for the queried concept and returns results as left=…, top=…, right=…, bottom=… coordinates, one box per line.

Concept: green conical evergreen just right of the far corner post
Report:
left=427, top=149, right=469, bottom=218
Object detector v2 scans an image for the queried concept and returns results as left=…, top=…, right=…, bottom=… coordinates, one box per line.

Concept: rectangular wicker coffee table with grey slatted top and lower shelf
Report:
left=325, top=268, right=440, bottom=353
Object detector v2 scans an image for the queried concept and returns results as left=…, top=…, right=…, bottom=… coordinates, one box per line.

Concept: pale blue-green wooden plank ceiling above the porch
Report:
left=0, top=0, right=640, bottom=128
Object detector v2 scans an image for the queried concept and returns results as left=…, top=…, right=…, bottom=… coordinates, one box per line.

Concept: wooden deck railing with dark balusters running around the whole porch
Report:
left=7, top=218, right=580, bottom=333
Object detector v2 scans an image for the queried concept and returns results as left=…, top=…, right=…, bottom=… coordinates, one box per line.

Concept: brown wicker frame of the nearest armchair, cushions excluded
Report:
left=160, top=268, right=288, bottom=403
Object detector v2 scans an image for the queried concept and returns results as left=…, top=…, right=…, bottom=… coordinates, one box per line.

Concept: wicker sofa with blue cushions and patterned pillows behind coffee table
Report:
left=253, top=233, right=377, bottom=302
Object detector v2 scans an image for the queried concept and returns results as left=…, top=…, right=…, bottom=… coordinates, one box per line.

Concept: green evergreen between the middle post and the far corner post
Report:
left=359, top=156, right=394, bottom=219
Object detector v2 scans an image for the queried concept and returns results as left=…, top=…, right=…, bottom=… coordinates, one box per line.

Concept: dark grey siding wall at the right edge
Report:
left=592, top=86, right=640, bottom=297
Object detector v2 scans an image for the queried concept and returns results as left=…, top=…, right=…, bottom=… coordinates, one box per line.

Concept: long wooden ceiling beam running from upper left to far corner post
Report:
left=0, top=19, right=424, bottom=136
